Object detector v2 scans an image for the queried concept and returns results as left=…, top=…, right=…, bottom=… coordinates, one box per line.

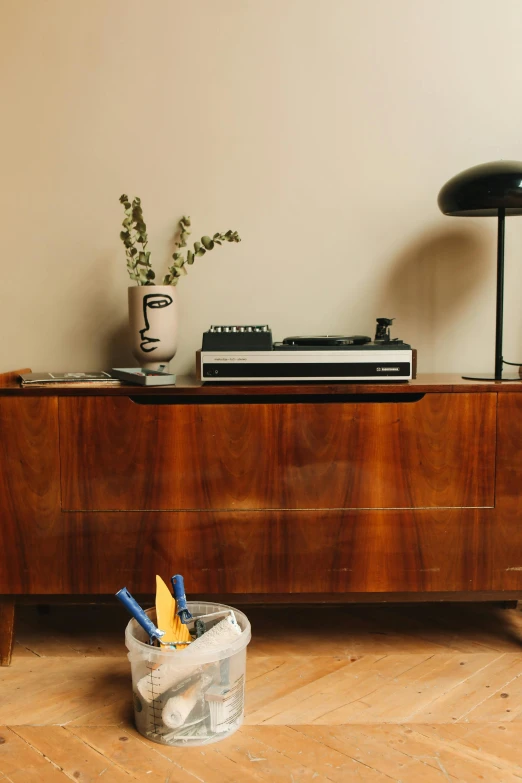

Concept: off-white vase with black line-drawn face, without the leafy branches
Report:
left=129, top=285, right=178, bottom=370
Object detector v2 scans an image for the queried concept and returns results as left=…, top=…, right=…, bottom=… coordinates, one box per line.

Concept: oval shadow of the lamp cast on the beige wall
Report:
left=376, top=227, right=488, bottom=364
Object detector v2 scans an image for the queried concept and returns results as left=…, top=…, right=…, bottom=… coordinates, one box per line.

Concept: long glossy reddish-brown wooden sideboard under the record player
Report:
left=0, top=373, right=522, bottom=663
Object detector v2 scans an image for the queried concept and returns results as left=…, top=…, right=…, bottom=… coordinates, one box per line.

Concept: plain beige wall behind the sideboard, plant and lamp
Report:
left=0, top=0, right=522, bottom=372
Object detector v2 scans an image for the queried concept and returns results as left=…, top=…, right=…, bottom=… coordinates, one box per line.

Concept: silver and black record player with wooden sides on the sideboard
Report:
left=197, top=318, right=416, bottom=383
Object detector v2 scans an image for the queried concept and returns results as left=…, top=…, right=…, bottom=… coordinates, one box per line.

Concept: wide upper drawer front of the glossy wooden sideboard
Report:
left=59, top=393, right=496, bottom=511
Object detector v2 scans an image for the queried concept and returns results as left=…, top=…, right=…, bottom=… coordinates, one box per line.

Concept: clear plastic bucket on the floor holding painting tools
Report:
left=125, top=601, right=251, bottom=746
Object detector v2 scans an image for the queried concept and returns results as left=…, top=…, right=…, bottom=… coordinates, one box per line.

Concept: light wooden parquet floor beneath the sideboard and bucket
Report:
left=0, top=605, right=522, bottom=783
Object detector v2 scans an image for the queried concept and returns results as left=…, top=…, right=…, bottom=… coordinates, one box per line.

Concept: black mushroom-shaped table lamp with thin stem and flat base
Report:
left=438, top=160, right=522, bottom=381
